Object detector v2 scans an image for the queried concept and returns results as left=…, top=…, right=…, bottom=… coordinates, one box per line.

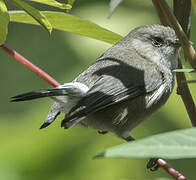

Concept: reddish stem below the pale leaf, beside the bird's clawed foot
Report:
left=157, top=159, right=188, bottom=180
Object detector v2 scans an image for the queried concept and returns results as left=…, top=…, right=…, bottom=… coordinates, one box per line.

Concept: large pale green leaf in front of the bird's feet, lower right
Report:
left=95, top=128, right=196, bottom=159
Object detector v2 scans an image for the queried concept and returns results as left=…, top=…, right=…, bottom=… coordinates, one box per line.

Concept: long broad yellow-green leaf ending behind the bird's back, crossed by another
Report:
left=9, top=11, right=122, bottom=44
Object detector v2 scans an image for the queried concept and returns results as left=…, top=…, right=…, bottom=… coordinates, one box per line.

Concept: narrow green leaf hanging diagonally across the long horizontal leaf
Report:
left=13, top=0, right=52, bottom=34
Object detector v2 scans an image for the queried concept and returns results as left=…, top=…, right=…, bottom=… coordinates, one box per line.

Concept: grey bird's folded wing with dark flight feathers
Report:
left=61, top=68, right=161, bottom=128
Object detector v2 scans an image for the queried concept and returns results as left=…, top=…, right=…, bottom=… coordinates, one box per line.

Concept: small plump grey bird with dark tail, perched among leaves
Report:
left=11, top=25, right=180, bottom=141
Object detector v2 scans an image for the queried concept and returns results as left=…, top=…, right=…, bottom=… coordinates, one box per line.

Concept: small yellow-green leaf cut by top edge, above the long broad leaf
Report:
left=31, top=0, right=72, bottom=10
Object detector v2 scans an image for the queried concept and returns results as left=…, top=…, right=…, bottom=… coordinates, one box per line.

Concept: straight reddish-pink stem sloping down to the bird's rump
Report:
left=0, top=44, right=60, bottom=87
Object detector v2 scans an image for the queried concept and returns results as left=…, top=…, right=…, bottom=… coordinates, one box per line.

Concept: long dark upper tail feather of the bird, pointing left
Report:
left=11, top=89, right=67, bottom=102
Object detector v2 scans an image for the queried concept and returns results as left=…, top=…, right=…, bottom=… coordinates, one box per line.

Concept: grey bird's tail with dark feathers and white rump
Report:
left=11, top=82, right=89, bottom=129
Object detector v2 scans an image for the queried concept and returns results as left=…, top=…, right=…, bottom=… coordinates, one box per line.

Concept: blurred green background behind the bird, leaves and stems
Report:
left=0, top=0, right=196, bottom=180
